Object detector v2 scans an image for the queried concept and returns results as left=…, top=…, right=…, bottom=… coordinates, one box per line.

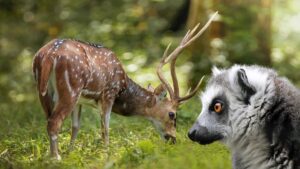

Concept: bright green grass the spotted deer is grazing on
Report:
left=0, top=99, right=231, bottom=169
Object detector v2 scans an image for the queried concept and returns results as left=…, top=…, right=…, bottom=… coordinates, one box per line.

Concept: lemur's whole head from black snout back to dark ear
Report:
left=188, top=68, right=256, bottom=144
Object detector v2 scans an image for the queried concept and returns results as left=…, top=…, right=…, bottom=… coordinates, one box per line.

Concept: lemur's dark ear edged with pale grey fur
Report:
left=237, top=69, right=256, bottom=104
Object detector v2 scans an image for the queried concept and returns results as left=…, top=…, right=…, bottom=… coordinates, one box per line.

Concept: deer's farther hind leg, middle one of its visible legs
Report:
left=70, top=104, right=82, bottom=145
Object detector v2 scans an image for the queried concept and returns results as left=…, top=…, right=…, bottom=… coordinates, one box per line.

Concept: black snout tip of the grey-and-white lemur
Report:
left=188, top=122, right=223, bottom=144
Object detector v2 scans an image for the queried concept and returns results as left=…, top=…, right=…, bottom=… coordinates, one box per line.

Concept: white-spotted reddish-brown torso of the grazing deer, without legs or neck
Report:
left=34, top=39, right=127, bottom=99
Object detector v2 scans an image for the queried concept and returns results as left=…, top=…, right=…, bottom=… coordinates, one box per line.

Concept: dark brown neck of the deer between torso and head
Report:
left=113, top=78, right=154, bottom=116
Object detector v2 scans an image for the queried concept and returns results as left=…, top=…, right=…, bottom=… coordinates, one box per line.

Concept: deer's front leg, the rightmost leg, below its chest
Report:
left=98, top=99, right=114, bottom=146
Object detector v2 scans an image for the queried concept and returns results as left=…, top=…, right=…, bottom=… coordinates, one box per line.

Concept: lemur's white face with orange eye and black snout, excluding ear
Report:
left=189, top=86, right=230, bottom=144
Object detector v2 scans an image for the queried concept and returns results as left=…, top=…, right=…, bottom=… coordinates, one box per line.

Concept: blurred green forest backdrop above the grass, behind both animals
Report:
left=0, top=0, right=300, bottom=106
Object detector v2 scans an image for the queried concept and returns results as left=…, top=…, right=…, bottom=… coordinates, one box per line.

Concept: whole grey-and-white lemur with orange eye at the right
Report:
left=189, top=65, right=300, bottom=169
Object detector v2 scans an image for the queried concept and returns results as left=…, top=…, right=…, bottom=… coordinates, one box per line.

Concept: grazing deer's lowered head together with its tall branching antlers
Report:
left=146, top=12, right=217, bottom=143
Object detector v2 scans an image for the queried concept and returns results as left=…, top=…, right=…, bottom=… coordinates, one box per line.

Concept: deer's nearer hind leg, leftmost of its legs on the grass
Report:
left=47, top=99, right=75, bottom=160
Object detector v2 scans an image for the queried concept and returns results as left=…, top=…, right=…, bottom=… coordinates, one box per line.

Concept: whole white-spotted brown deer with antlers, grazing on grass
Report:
left=33, top=12, right=213, bottom=159
